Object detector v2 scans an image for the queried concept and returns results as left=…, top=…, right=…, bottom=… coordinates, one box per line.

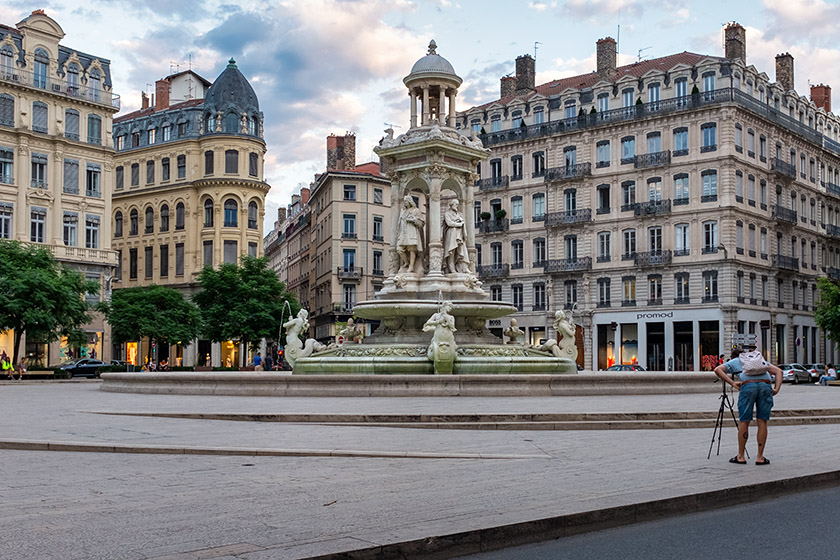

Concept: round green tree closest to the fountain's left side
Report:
left=193, top=256, right=300, bottom=365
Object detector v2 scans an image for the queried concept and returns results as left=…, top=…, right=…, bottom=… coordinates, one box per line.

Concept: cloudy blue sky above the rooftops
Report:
left=0, top=0, right=840, bottom=233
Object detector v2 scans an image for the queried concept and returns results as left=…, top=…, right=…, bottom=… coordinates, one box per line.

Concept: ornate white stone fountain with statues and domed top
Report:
left=287, top=41, right=576, bottom=374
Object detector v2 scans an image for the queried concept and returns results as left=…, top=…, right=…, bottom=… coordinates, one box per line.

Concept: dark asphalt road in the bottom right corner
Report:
left=462, top=488, right=840, bottom=560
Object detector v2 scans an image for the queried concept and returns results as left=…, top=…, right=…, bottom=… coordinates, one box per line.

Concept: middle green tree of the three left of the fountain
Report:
left=99, top=284, right=201, bottom=364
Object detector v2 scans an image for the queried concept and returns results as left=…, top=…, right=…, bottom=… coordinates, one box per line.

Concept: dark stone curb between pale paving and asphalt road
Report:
left=307, top=471, right=840, bottom=560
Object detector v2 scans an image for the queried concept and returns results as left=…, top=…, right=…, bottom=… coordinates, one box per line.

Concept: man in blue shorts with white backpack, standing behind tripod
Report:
left=715, top=343, right=782, bottom=465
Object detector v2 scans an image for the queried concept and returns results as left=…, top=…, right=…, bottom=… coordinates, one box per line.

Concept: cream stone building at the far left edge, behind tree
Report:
left=0, top=10, right=120, bottom=365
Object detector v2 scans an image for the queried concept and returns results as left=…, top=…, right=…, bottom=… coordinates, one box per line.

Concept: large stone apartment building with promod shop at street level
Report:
left=457, top=23, right=840, bottom=371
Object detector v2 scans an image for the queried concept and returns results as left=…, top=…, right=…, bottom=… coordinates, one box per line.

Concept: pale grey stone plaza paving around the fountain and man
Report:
left=0, top=381, right=840, bottom=560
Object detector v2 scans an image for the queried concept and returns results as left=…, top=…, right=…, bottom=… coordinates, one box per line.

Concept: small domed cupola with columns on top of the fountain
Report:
left=403, top=40, right=463, bottom=128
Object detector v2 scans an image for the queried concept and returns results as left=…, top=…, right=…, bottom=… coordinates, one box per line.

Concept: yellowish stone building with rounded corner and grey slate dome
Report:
left=111, top=59, right=270, bottom=366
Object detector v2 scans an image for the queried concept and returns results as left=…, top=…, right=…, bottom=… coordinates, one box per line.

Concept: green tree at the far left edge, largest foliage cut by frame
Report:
left=0, top=240, right=99, bottom=361
